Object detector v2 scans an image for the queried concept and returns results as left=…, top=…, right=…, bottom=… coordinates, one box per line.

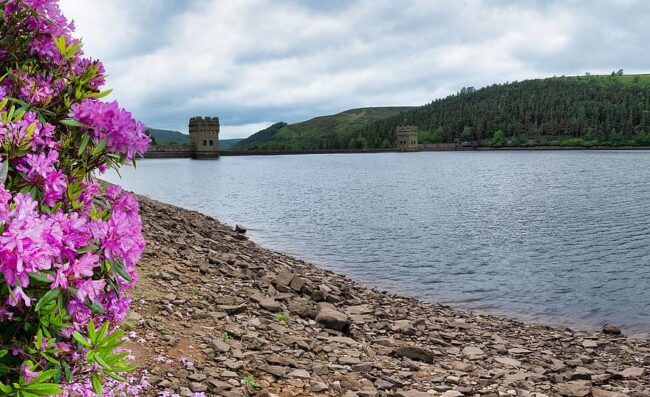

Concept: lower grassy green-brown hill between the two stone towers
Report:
left=234, top=107, right=413, bottom=150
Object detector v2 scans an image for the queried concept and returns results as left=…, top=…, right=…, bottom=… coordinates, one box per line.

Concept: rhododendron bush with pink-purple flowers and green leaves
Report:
left=0, top=0, right=149, bottom=397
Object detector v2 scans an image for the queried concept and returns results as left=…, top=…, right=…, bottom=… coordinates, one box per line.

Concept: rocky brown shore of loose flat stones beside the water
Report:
left=126, top=197, right=650, bottom=397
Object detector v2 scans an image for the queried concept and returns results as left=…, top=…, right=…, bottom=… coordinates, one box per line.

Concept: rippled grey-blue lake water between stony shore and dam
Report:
left=106, top=151, right=650, bottom=332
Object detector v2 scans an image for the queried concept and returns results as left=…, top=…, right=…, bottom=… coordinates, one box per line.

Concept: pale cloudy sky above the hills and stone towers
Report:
left=61, top=0, right=650, bottom=138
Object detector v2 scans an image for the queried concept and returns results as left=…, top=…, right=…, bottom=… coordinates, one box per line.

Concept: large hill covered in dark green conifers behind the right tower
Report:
left=359, top=74, right=650, bottom=147
